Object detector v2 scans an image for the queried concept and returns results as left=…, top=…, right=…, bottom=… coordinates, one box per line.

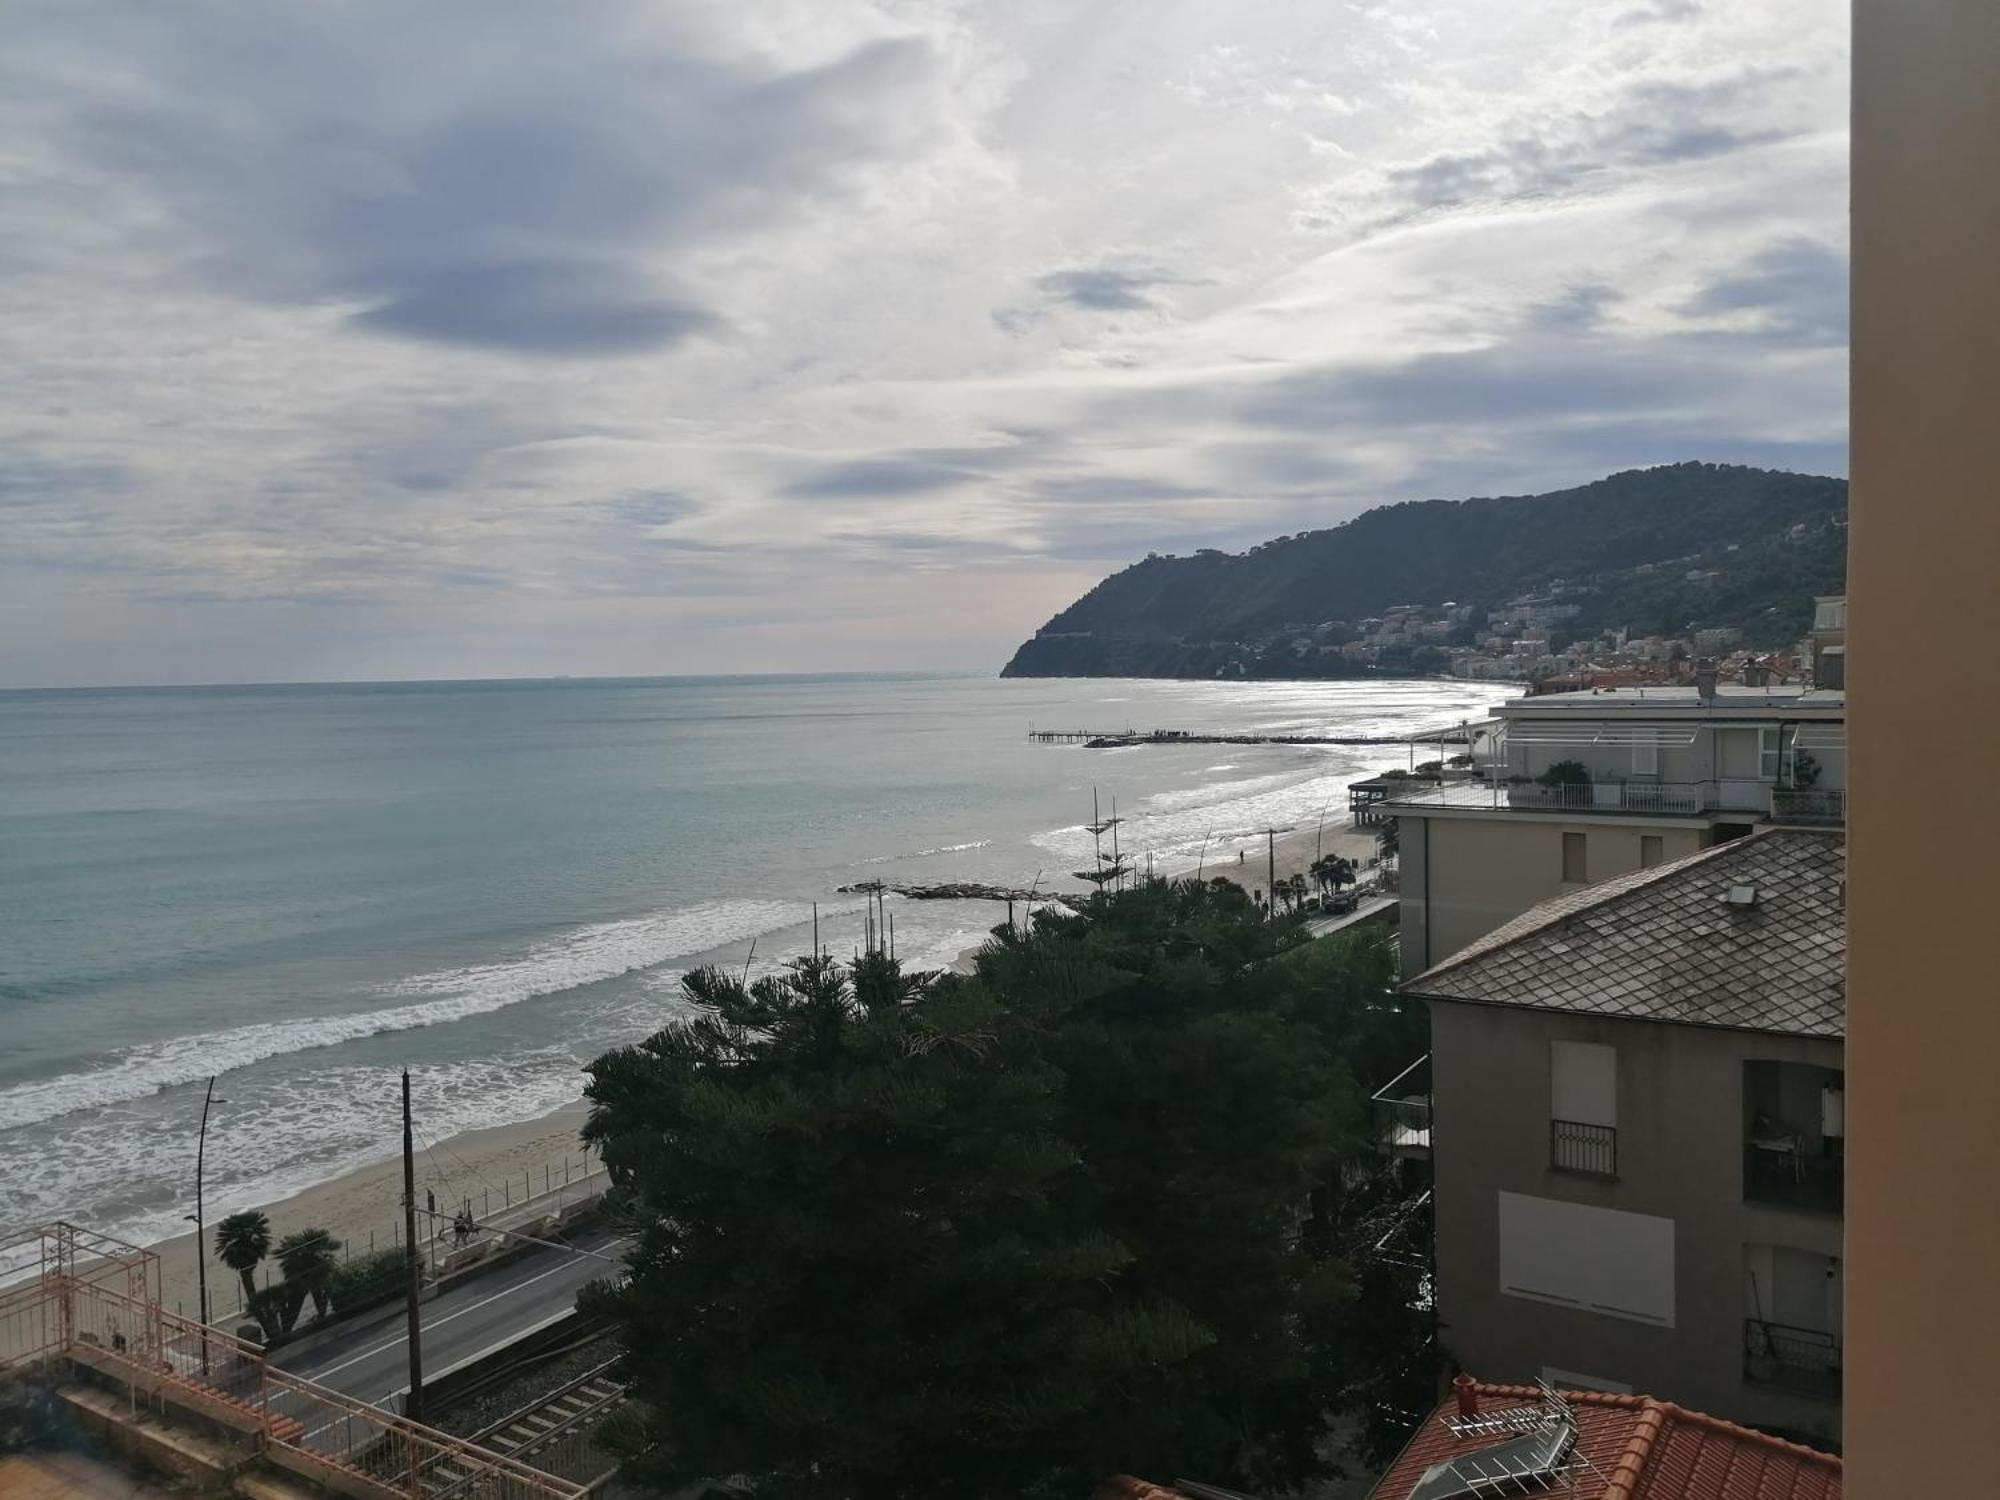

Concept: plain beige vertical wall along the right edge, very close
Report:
left=1846, top=0, right=2000, bottom=1500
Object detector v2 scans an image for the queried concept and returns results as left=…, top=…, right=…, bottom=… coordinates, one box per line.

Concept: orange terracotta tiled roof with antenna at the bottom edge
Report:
left=1370, top=1384, right=1840, bottom=1500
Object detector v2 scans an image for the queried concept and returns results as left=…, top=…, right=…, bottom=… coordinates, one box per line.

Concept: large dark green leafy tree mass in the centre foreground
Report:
left=586, top=880, right=1430, bottom=1500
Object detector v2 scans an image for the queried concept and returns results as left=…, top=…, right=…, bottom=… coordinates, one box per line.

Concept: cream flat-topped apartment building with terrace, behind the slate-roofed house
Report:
left=1372, top=674, right=1846, bottom=976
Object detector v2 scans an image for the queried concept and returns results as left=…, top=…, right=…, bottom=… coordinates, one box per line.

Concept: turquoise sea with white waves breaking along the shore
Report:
left=0, top=674, right=1508, bottom=1242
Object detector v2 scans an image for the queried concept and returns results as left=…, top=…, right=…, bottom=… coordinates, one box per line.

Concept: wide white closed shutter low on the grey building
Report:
left=1500, top=1192, right=1674, bottom=1328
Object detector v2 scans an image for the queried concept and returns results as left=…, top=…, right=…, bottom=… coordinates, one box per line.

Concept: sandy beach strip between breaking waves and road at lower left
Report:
left=152, top=1098, right=588, bottom=1324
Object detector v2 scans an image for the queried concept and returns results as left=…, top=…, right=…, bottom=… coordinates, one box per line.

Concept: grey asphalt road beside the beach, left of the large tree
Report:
left=272, top=1230, right=624, bottom=1410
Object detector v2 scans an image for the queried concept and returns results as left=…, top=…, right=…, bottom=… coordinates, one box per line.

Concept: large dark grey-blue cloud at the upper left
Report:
left=21, top=0, right=934, bottom=358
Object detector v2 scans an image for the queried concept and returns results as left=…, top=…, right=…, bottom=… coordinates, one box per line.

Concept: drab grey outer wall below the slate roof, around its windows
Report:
left=1430, top=1002, right=1842, bottom=1438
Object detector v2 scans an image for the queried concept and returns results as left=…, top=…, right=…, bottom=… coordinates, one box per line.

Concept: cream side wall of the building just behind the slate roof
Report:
left=1398, top=812, right=1714, bottom=978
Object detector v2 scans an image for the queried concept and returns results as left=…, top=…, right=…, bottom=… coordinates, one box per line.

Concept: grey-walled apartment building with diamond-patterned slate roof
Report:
left=1402, top=828, right=1846, bottom=1442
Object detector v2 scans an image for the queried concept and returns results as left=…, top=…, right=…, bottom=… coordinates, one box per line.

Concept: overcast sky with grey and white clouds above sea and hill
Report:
left=0, top=0, right=1848, bottom=686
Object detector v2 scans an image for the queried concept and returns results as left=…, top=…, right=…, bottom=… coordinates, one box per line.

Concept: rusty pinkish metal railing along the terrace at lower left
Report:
left=0, top=1224, right=584, bottom=1500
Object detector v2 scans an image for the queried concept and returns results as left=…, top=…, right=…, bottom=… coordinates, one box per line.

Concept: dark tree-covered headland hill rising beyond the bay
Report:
left=1002, top=464, right=1848, bottom=676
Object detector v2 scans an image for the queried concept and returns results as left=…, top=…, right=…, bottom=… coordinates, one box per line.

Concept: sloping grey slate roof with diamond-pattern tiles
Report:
left=1402, top=828, right=1848, bottom=1036
